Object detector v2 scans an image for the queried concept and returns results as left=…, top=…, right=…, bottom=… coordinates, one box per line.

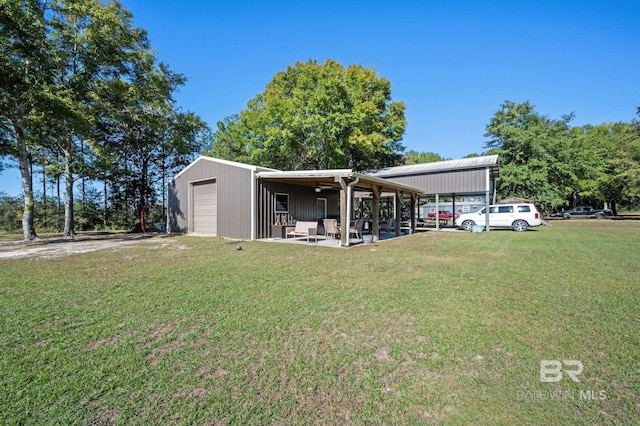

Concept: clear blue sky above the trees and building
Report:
left=0, top=0, right=640, bottom=195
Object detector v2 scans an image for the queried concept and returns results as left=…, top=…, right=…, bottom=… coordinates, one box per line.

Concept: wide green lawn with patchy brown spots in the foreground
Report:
left=0, top=220, right=640, bottom=425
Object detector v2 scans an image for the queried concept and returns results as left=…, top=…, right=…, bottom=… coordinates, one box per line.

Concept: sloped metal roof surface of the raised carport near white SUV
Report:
left=367, top=154, right=500, bottom=178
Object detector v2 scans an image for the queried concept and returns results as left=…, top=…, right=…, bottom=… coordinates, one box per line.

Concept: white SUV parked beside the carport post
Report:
left=455, top=204, right=542, bottom=231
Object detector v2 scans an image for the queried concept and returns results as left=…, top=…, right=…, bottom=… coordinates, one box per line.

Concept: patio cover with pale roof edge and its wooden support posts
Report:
left=257, top=169, right=423, bottom=247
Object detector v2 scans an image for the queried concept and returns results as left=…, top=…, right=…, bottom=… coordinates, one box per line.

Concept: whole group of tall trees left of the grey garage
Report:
left=0, top=0, right=208, bottom=240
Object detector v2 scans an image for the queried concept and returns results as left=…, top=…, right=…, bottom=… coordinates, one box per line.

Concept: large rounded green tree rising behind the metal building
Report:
left=211, top=59, right=406, bottom=170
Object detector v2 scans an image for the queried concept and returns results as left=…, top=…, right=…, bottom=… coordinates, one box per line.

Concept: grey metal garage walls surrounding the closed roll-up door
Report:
left=167, top=159, right=253, bottom=239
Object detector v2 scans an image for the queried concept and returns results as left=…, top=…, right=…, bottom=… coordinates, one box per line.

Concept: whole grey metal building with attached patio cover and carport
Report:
left=167, top=155, right=499, bottom=241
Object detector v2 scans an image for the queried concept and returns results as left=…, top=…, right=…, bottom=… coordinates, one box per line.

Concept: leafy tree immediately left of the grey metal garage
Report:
left=94, top=56, right=208, bottom=231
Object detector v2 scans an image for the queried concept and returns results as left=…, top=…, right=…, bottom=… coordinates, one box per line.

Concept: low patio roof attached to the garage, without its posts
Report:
left=256, top=169, right=422, bottom=195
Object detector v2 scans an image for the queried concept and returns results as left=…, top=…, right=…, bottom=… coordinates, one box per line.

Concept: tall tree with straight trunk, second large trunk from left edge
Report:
left=44, top=0, right=155, bottom=237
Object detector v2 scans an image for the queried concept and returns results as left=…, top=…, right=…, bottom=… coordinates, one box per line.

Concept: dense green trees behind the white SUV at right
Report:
left=485, top=101, right=640, bottom=209
